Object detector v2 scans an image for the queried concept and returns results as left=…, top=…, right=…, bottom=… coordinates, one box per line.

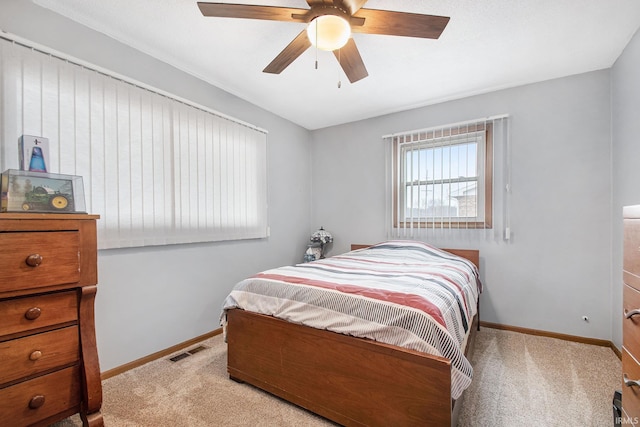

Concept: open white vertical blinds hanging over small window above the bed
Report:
left=383, top=115, right=510, bottom=242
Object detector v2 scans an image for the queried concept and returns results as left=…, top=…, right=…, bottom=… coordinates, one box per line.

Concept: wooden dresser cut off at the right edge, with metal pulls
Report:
left=622, top=205, right=640, bottom=425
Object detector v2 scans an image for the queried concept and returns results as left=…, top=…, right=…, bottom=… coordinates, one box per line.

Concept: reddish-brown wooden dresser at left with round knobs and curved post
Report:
left=0, top=213, right=103, bottom=427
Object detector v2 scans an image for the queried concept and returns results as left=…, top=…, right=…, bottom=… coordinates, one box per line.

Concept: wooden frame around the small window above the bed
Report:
left=392, top=123, right=494, bottom=229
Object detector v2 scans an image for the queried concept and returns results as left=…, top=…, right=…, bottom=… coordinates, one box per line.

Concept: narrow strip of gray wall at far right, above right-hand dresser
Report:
left=611, top=26, right=640, bottom=348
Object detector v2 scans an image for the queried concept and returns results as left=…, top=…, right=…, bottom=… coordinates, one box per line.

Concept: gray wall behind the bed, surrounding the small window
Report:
left=312, top=70, right=611, bottom=340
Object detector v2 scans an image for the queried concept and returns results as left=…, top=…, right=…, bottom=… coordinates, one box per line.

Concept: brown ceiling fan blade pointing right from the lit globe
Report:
left=351, top=9, right=449, bottom=39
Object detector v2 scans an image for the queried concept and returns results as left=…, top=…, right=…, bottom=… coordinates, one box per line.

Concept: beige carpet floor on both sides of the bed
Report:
left=54, top=328, right=621, bottom=427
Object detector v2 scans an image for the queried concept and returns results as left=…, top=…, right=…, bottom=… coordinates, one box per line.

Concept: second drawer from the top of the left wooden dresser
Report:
left=0, top=292, right=78, bottom=339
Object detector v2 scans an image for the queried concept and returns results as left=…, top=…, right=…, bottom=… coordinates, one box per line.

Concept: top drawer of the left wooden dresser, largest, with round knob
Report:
left=0, top=231, right=80, bottom=292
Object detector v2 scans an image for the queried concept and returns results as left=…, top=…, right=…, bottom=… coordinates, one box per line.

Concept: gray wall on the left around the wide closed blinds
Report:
left=0, top=0, right=313, bottom=371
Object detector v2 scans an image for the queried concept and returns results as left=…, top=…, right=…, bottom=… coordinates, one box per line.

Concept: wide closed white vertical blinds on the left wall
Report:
left=0, top=36, right=268, bottom=249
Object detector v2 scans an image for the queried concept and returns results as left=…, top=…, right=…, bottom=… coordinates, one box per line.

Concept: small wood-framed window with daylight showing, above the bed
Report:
left=394, top=124, right=493, bottom=228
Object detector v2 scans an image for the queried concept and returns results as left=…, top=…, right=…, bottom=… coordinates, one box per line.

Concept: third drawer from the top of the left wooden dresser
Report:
left=0, top=326, right=80, bottom=384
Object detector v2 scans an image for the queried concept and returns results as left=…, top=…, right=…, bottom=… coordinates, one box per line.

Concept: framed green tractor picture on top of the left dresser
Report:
left=1, top=169, right=86, bottom=213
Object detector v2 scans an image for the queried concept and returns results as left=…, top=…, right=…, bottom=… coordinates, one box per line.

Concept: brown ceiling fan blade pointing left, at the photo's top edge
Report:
left=198, top=2, right=309, bottom=22
